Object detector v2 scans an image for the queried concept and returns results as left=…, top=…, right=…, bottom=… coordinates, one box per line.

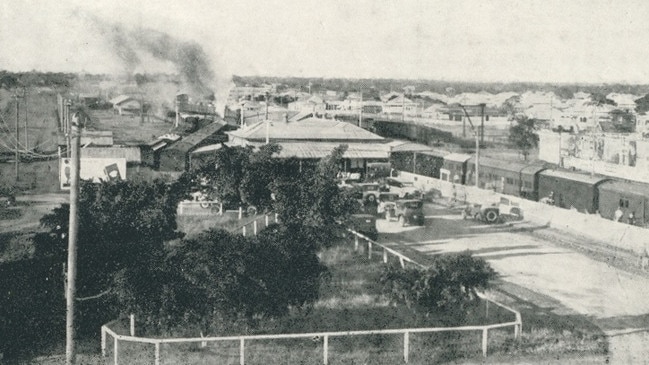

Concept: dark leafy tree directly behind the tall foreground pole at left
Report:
left=35, top=181, right=187, bottom=318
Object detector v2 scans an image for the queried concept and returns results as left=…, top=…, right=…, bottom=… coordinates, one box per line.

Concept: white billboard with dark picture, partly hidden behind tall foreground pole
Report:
left=59, top=158, right=126, bottom=190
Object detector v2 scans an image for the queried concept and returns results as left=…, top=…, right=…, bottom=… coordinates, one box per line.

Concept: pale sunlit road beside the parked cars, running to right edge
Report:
left=378, top=205, right=649, bottom=364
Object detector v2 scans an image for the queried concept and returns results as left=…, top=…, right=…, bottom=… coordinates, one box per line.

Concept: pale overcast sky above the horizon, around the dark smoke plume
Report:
left=0, top=0, right=649, bottom=83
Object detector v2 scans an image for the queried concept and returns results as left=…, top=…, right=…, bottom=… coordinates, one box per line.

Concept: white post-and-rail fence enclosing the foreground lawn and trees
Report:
left=101, top=228, right=523, bottom=365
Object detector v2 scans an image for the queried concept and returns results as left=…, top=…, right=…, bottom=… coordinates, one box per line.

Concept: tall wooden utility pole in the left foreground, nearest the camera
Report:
left=65, top=110, right=81, bottom=365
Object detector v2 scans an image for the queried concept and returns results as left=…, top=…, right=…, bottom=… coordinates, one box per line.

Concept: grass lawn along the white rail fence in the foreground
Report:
left=97, top=240, right=606, bottom=364
